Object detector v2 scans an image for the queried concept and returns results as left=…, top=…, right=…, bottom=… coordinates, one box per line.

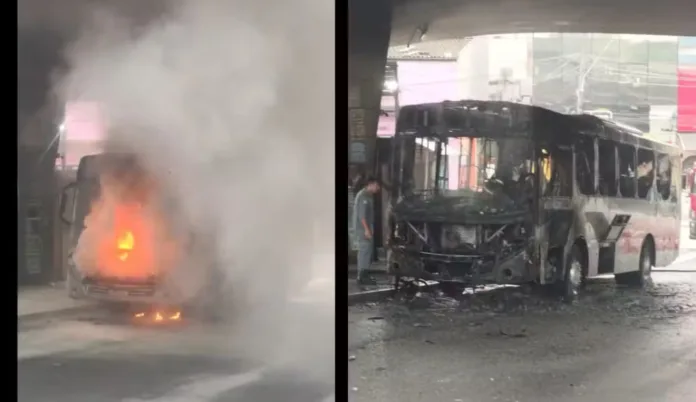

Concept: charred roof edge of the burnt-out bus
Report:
left=396, top=100, right=681, bottom=154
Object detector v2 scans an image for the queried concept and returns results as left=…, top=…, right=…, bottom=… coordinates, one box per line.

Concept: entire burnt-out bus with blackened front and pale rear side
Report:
left=389, top=101, right=681, bottom=300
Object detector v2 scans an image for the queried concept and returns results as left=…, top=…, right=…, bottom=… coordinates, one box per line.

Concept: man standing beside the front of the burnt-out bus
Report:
left=353, top=177, right=380, bottom=285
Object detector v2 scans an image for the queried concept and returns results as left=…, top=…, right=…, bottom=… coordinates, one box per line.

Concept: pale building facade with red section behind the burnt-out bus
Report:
left=381, top=33, right=696, bottom=166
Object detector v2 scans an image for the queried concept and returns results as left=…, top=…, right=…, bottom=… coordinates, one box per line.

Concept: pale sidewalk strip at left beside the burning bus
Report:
left=17, top=283, right=94, bottom=320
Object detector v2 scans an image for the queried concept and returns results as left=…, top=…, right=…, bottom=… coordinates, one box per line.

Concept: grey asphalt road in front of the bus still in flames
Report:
left=17, top=304, right=334, bottom=402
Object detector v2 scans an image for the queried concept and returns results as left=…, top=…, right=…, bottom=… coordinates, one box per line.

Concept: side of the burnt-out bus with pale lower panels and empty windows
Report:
left=541, top=116, right=681, bottom=287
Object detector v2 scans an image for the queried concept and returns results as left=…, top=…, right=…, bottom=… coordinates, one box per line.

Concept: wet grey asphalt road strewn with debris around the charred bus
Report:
left=348, top=256, right=696, bottom=402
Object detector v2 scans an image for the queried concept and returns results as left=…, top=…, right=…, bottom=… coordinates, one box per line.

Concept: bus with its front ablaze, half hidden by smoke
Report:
left=61, top=153, right=222, bottom=319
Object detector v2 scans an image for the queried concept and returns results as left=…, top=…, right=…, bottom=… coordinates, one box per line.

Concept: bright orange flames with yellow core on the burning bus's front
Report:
left=75, top=156, right=182, bottom=280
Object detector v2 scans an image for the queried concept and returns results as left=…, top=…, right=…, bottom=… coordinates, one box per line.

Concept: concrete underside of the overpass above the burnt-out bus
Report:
left=390, top=0, right=696, bottom=47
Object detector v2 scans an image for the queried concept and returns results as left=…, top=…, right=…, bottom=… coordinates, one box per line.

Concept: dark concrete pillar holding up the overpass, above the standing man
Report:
left=348, top=0, right=392, bottom=181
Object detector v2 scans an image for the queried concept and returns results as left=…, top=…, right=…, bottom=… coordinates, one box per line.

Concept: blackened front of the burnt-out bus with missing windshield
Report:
left=390, top=102, right=536, bottom=285
